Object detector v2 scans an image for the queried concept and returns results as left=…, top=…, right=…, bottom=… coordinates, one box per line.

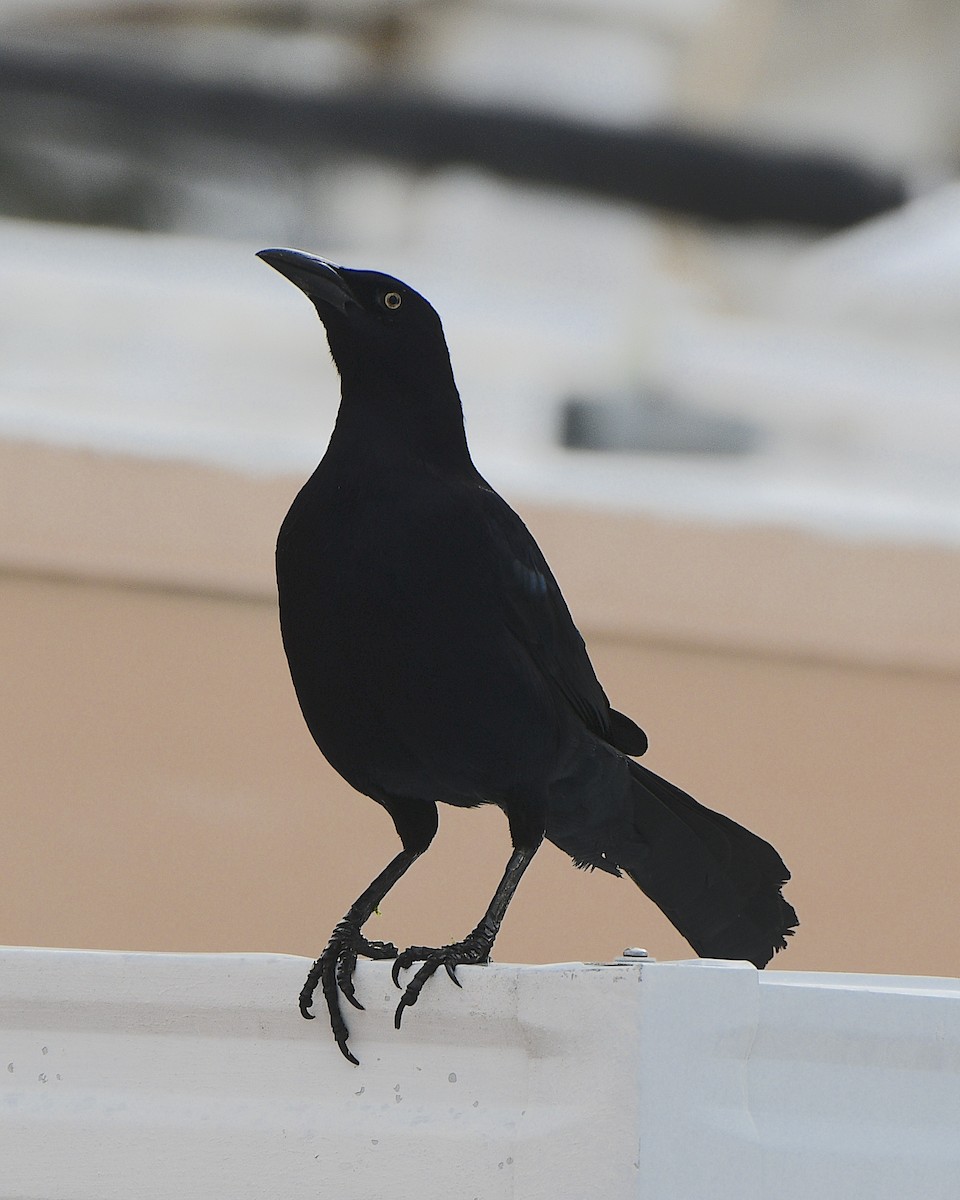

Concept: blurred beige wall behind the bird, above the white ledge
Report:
left=0, top=446, right=960, bottom=974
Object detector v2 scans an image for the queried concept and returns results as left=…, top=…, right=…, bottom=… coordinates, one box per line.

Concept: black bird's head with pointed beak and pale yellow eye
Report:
left=257, top=250, right=456, bottom=402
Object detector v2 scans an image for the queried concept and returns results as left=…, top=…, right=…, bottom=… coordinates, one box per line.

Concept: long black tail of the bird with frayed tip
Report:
left=547, top=758, right=798, bottom=967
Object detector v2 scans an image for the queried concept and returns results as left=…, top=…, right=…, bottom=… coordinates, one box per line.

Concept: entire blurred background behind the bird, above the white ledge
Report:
left=0, top=0, right=960, bottom=974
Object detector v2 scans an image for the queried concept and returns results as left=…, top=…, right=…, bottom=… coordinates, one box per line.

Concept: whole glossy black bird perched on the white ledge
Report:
left=259, top=250, right=797, bottom=1063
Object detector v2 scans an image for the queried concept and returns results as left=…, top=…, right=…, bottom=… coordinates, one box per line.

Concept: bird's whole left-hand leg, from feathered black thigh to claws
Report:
left=300, top=800, right=437, bottom=1066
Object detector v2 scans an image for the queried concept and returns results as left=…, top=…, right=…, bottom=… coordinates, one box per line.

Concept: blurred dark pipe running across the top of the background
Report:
left=0, top=48, right=906, bottom=229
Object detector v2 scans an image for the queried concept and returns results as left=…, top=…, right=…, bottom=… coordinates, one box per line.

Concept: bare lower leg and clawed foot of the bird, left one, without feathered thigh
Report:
left=300, top=850, right=420, bottom=1066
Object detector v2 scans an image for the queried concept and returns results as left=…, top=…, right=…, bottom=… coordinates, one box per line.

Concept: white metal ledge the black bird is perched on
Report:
left=0, top=949, right=960, bottom=1200
